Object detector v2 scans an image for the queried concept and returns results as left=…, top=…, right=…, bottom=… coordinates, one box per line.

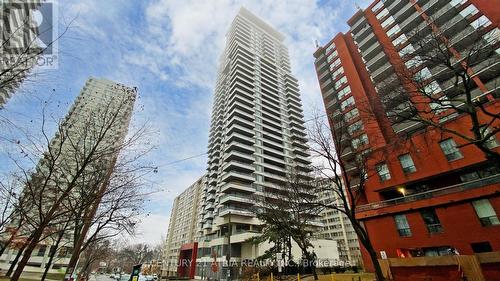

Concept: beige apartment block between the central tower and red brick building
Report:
left=315, top=186, right=362, bottom=265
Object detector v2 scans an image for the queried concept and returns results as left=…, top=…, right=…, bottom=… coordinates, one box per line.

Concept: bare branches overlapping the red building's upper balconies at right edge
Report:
left=378, top=15, right=500, bottom=164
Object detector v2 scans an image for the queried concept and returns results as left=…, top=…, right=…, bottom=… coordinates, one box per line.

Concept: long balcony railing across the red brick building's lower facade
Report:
left=356, top=174, right=500, bottom=212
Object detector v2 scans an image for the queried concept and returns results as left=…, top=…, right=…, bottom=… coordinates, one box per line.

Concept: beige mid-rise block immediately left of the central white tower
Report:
left=162, top=176, right=205, bottom=276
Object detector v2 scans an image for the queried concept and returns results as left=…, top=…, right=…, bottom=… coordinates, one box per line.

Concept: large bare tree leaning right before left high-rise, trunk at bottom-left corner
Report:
left=0, top=88, right=145, bottom=281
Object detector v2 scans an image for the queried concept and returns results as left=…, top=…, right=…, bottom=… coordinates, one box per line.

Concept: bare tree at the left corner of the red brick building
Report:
left=303, top=114, right=384, bottom=281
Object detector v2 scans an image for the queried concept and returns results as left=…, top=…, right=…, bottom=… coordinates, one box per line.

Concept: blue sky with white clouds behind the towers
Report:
left=0, top=0, right=370, bottom=245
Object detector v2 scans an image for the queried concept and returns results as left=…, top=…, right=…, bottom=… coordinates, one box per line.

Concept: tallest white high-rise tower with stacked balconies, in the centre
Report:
left=195, top=5, right=310, bottom=275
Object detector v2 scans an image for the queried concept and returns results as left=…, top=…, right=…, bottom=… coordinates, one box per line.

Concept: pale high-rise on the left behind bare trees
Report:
left=0, top=78, right=137, bottom=273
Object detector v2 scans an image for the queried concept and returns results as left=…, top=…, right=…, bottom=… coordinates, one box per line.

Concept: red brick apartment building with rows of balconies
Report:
left=314, top=0, right=500, bottom=280
